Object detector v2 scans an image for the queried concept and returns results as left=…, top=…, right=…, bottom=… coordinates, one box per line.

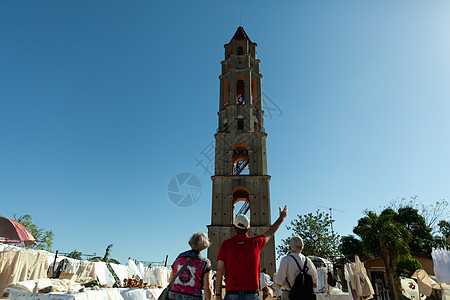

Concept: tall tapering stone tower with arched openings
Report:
left=208, top=27, right=275, bottom=274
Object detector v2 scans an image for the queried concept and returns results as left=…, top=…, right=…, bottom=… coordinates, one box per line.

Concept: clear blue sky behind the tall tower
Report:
left=0, top=0, right=450, bottom=263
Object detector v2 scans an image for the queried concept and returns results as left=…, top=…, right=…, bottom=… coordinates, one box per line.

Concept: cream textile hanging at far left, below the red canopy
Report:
left=0, top=247, right=48, bottom=294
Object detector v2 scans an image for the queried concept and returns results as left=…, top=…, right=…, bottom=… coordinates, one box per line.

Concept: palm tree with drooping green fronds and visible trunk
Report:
left=353, top=210, right=411, bottom=299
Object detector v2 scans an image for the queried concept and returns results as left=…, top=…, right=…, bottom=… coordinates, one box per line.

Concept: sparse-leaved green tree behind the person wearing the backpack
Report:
left=277, top=210, right=342, bottom=261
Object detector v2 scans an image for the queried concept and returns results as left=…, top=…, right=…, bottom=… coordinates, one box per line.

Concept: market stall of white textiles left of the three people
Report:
left=0, top=244, right=170, bottom=300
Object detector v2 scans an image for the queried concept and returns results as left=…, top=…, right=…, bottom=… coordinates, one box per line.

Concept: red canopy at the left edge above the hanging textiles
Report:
left=0, top=217, right=37, bottom=246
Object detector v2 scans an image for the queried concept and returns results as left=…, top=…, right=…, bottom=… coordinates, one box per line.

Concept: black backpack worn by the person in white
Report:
left=286, top=255, right=316, bottom=300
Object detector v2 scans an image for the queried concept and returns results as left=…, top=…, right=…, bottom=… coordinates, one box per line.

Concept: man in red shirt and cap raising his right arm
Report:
left=216, top=206, right=287, bottom=300
